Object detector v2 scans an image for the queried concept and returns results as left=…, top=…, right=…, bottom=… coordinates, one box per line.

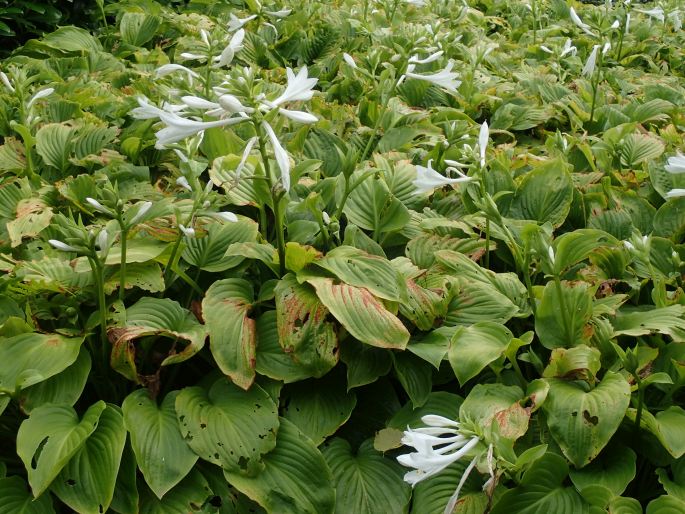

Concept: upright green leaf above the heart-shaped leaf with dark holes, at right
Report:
left=535, top=281, right=592, bottom=350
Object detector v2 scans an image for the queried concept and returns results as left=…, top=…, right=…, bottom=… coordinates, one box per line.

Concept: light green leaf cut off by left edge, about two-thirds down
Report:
left=0, top=332, right=83, bottom=394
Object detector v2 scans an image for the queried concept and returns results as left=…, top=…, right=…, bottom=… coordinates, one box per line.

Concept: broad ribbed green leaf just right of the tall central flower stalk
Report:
left=344, top=172, right=410, bottom=235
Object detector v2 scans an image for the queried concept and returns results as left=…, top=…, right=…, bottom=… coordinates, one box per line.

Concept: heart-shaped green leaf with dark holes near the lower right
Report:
left=542, top=371, right=630, bottom=468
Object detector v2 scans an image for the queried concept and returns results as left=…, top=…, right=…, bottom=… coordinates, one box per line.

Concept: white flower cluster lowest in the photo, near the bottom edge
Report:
left=397, top=415, right=480, bottom=487
